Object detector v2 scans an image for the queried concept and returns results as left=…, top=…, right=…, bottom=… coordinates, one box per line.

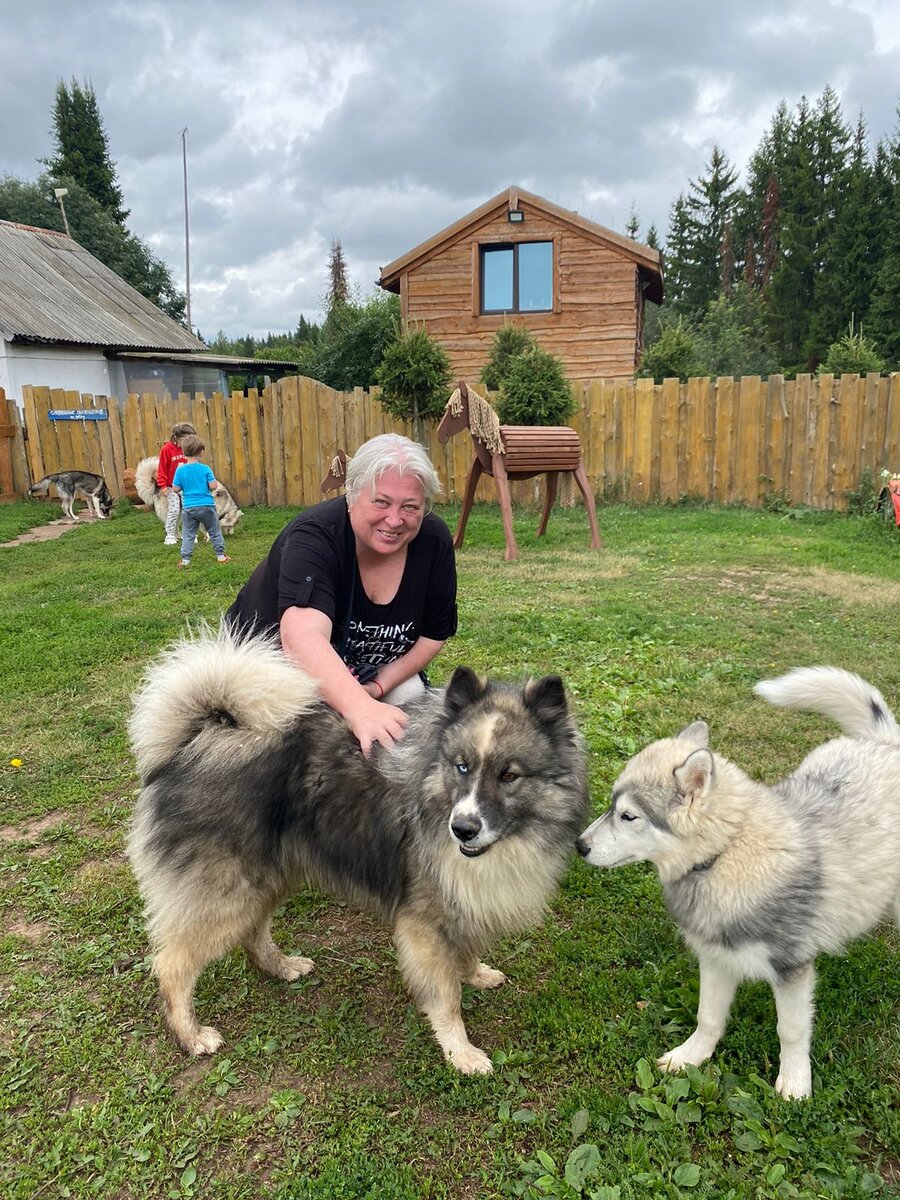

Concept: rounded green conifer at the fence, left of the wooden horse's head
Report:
left=376, top=328, right=452, bottom=439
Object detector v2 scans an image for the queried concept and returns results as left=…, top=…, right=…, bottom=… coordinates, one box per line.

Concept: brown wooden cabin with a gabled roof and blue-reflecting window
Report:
left=378, top=187, right=662, bottom=380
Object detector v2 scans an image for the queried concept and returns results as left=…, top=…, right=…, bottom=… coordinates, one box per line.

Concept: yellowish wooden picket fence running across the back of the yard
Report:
left=12, top=374, right=900, bottom=509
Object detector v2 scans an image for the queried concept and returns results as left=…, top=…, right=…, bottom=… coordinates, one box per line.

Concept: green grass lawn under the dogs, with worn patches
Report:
left=0, top=504, right=900, bottom=1200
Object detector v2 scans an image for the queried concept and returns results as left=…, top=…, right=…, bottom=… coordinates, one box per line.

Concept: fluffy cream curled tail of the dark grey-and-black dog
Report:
left=128, top=619, right=319, bottom=779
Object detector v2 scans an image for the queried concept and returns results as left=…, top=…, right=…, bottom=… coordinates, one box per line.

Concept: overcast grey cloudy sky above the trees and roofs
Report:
left=0, top=0, right=900, bottom=338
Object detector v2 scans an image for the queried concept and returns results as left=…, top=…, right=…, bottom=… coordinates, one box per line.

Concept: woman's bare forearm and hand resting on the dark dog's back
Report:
left=281, top=607, right=410, bottom=755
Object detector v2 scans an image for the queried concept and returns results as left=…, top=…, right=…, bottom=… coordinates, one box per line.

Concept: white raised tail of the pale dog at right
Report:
left=754, top=667, right=900, bottom=742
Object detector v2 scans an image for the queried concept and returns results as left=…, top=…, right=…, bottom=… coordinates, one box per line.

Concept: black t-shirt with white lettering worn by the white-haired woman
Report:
left=227, top=496, right=456, bottom=666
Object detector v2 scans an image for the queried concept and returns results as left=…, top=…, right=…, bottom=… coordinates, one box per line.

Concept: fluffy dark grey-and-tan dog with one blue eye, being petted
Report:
left=128, top=625, right=587, bottom=1073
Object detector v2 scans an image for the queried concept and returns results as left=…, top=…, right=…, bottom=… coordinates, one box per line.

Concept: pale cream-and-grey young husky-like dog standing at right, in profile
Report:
left=578, top=667, right=900, bottom=1097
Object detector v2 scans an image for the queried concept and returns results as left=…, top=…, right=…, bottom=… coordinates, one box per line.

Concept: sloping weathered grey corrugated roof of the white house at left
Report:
left=0, top=221, right=206, bottom=350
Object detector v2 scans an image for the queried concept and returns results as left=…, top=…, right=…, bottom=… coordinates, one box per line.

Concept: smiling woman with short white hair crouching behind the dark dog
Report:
left=227, top=433, right=456, bottom=754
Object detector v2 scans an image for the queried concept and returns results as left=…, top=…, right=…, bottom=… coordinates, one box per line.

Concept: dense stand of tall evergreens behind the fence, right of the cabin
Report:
left=642, top=86, right=900, bottom=374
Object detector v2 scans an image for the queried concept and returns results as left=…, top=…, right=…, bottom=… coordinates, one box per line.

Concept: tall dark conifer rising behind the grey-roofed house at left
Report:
left=46, top=79, right=128, bottom=228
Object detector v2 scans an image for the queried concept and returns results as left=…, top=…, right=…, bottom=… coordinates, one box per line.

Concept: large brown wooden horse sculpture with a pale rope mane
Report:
left=438, top=379, right=602, bottom=563
